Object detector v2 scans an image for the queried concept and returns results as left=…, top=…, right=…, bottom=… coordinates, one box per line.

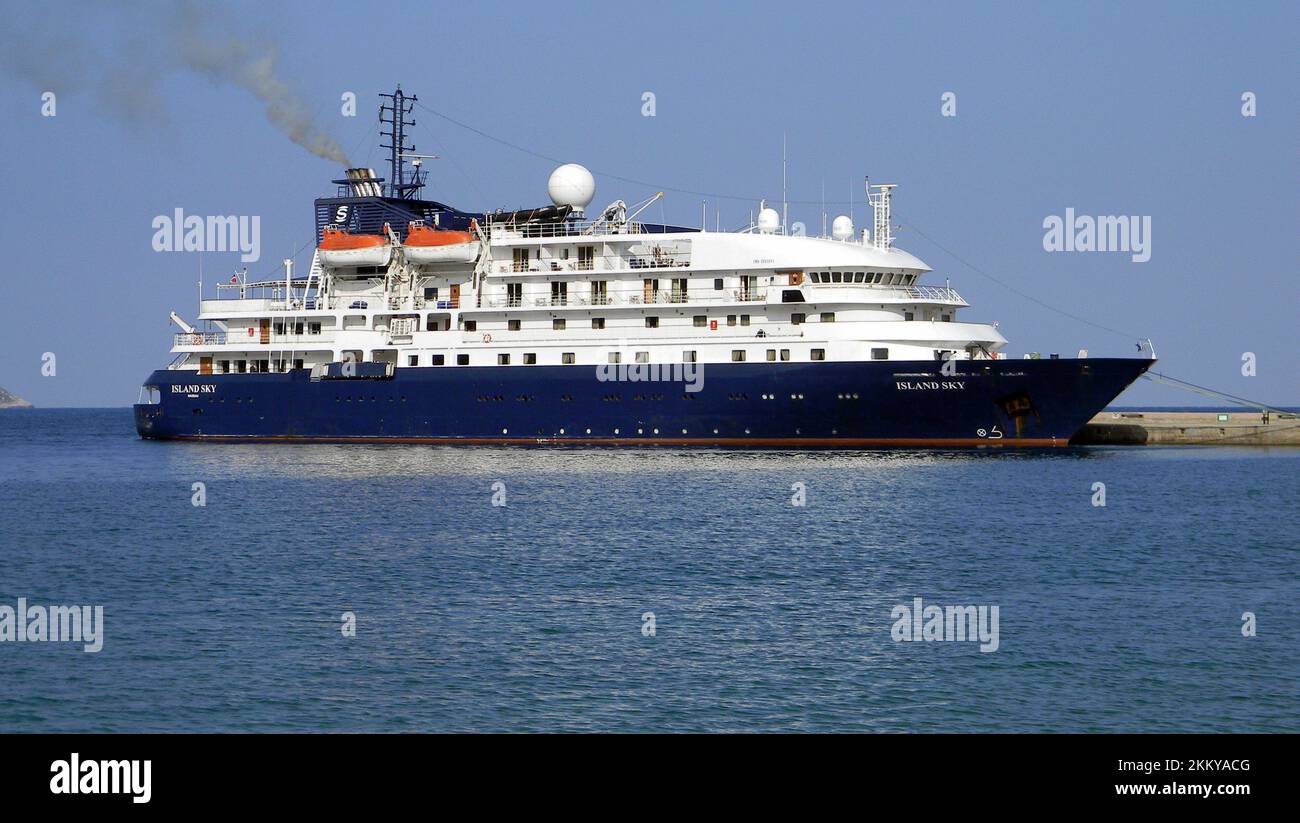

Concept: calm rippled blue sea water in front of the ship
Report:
left=0, top=410, right=1300, bottom=732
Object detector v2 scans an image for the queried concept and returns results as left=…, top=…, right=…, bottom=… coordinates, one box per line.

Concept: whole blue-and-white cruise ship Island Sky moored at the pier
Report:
left=134, top=88, right=1153, bottom=449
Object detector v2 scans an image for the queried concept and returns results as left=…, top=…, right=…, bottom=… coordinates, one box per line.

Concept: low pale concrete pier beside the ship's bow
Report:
left=1070, top=412, right=1300, bottom=446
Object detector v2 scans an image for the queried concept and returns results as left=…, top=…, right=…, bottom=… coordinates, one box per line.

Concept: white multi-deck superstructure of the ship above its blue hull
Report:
left=172, top=178, right=1006, bottom=373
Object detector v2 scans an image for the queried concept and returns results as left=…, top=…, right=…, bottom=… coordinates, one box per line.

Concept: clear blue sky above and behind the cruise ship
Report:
left=0, top=3, right=1300, bottom=406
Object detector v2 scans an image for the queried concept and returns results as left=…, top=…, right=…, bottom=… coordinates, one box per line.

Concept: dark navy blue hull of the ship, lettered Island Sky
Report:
left=135, top=359, right=1153, bottom=447
